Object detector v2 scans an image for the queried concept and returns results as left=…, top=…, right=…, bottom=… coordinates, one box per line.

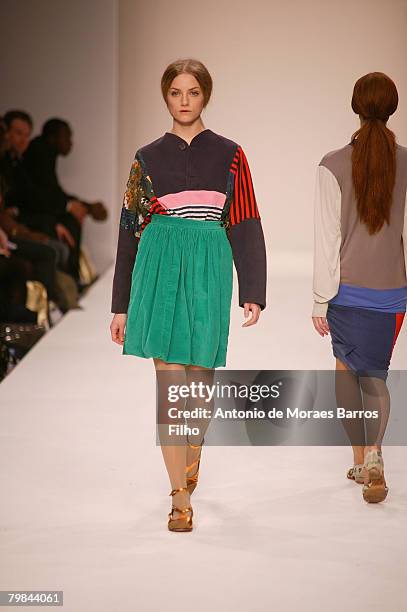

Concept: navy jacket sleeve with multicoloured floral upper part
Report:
left=111, top=153, right=145, bottom=313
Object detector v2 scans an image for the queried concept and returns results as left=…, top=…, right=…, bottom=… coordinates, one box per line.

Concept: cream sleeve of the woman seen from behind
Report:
left=312, top=165, right=341, bottom=317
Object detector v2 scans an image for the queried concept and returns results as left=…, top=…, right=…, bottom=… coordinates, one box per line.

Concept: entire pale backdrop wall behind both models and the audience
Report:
left=0, top=0, right=407, bottom=271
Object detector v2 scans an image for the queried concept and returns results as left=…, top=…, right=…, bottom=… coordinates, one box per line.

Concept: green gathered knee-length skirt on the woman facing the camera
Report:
left=123, top=214, right=233, bottom=368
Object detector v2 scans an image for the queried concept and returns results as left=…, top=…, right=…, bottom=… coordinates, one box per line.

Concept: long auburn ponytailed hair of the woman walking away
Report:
left=351, top=72, right=398, bottom=234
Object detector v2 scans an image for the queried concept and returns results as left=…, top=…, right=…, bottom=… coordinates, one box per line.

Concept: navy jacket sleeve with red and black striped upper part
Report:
left=228, top=146, right=267, bottom=310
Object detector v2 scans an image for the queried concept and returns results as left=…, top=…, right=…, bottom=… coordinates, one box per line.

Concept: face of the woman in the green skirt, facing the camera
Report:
left=167, top=74, right=204, bottom=125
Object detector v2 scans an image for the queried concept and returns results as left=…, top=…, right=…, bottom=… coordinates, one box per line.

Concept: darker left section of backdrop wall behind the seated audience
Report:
left=0, top=0, right=118, bottom=272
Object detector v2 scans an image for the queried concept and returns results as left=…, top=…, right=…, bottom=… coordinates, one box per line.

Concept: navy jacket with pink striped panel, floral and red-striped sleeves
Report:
left=111, top=129, right=267, bottom=313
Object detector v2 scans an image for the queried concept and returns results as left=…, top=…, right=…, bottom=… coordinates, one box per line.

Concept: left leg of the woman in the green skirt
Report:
left=154, top=359, right=190, bottom=519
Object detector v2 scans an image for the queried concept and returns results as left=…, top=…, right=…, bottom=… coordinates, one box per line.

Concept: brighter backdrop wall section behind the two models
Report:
left=119, top=0, right=407, bottom=261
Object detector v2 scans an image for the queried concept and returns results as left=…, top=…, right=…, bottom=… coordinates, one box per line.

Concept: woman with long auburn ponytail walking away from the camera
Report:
left=312, top=72, right=407, bottom=502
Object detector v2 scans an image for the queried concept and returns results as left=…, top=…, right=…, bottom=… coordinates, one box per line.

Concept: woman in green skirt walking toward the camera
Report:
left=110, top=59, right=266, bottom=531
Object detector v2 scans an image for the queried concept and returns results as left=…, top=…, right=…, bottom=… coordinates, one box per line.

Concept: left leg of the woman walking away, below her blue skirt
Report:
left=335, top=358, right=365, bottom=465
